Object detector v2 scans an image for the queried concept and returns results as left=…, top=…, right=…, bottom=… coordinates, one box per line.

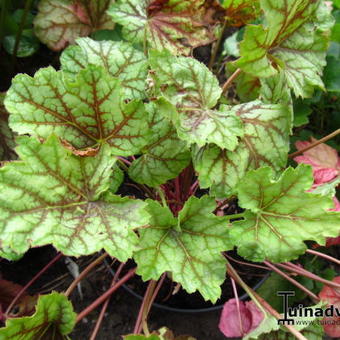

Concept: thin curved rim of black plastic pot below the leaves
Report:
left=104, top=260, right=270, bottom=313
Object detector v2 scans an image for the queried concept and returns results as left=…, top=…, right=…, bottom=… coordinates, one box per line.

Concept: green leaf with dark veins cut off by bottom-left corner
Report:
left=0, top=292, right=76, bottom=340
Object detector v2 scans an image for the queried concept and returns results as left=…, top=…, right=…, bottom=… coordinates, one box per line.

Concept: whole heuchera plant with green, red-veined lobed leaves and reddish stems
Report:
left=0, top=0, right=340, bottom=340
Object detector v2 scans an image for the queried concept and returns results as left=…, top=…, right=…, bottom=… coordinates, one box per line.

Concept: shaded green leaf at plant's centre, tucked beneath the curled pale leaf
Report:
left=129, top=101, right=191, bottom=187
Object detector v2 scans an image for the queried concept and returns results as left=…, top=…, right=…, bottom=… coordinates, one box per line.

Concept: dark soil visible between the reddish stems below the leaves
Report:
left=0, top=246, right=263, bottom=340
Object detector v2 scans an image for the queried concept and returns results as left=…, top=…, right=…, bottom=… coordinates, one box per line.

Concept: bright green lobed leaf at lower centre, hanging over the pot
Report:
left=134, top=196, right=233, bottom=302
